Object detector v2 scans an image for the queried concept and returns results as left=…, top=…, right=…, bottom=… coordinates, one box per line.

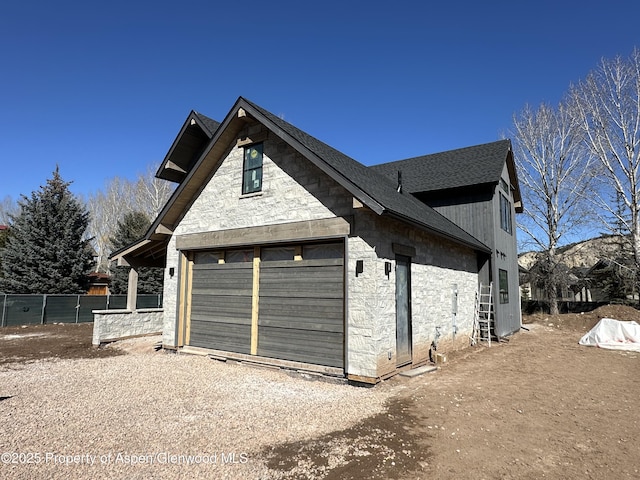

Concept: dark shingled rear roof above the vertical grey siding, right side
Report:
left=370, top=140, right=522, bottom=211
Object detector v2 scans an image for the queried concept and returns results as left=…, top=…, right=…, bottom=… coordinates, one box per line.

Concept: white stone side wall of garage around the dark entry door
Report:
left=347, top=210, right=478, bottom=378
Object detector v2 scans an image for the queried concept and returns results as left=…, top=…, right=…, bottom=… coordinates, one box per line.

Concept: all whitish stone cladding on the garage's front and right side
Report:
left=162, top=121, right=477, bottom=378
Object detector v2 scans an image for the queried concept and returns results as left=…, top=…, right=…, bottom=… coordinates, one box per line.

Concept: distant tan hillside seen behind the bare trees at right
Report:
left=518, top=235, right=621, bottom=269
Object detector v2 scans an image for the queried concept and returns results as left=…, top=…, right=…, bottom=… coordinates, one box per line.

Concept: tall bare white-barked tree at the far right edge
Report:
left=571, top=48, right=640, bottom=296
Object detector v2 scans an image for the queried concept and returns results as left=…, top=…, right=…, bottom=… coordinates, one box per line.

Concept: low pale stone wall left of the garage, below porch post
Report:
left=91, top=308, right=164, bottom=346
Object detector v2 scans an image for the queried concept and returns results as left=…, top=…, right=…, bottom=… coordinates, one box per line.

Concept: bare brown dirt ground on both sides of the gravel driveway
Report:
left=0, top=306, right=640, bottom=479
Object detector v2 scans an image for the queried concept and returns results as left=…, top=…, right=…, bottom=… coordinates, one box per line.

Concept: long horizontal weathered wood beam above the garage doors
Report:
left=176, top=217, right=351, bottom=250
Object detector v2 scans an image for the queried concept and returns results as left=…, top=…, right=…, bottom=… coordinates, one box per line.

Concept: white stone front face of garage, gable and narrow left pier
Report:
left=162, top=127, right=352, bottom=346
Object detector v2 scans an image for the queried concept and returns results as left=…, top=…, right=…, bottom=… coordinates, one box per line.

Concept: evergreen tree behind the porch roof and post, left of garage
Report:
left=109, top=211, right=164, bottom=294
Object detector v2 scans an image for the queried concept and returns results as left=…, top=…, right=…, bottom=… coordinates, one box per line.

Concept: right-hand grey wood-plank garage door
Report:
left=258, top=242, right=344, bottom=367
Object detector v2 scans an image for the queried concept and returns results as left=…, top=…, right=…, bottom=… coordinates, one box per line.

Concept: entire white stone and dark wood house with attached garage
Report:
left=106, top=98, right=521, bottom=383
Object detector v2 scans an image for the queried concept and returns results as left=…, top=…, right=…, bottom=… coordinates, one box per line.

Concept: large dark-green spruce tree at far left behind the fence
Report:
left=0, top=167, right=94, bottom=294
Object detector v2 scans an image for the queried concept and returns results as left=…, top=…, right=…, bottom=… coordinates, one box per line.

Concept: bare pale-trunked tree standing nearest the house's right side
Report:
left=513, top=102, right=593, bottom=314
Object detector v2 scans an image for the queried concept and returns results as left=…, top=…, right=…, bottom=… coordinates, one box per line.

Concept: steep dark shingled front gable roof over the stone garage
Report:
left=111, top=97, right=491, bottom=264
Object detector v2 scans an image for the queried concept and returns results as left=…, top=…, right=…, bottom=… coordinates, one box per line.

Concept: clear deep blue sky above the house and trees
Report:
left=0, top=0, right=640, bottom=200
